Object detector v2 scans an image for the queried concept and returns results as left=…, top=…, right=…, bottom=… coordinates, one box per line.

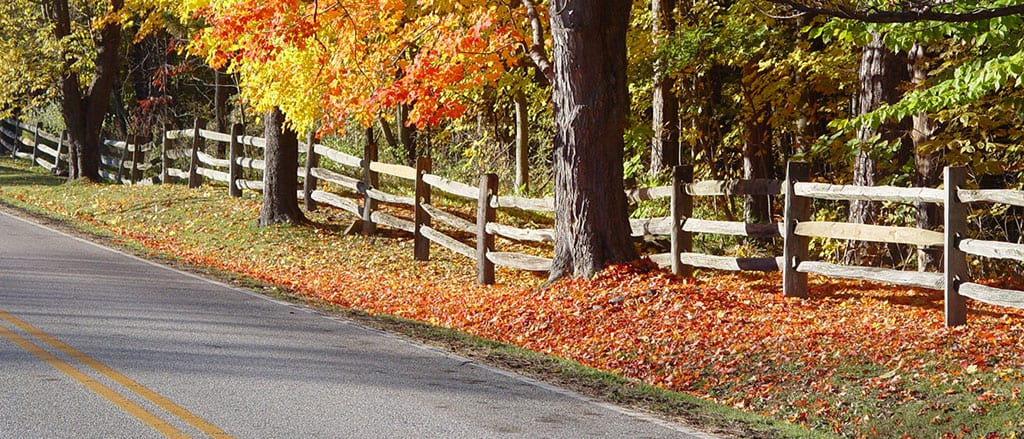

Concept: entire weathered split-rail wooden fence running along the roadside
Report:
left=0, top=116, right=1024, bottom=326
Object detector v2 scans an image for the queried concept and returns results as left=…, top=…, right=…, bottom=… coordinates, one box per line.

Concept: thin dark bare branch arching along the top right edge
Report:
left=765, top=0, right=1024, bottom=24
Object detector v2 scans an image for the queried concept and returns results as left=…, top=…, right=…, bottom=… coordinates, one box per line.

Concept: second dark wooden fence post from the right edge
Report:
left=780, top=162, right=811, bottom=298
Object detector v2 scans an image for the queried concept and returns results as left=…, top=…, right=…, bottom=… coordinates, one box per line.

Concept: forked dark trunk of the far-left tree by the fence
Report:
left=50, top=0, right=123, bottom=181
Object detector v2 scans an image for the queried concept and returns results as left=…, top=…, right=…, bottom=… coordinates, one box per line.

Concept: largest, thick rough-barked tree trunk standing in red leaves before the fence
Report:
left=550, top=0, right=637, bottom=280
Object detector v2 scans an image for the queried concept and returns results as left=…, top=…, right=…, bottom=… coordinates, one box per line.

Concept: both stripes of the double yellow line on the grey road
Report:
left=0, top=309, right=231, bottom=438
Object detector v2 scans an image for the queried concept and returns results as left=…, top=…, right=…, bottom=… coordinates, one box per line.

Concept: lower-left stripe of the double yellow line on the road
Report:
left=0, top=319, right=188, bottom=438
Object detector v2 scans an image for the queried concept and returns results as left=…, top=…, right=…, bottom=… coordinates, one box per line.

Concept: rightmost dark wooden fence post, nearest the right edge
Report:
left=942, top=167, right=968, bottom=327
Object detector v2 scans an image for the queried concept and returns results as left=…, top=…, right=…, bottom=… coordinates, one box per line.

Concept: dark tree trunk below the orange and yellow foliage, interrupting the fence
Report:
left=259, top=107, right=305, bottom=225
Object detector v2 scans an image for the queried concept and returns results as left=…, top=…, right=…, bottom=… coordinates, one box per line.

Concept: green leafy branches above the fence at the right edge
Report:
left=808, top=4, right=1024, bottom=180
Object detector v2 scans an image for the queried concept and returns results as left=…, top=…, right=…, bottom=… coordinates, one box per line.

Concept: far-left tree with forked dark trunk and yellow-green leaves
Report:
left=0, top=0, right=174, bottom=181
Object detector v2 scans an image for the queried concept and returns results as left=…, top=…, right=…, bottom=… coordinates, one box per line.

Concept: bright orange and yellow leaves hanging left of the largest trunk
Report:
left=185, top=0, right=522, bottom=131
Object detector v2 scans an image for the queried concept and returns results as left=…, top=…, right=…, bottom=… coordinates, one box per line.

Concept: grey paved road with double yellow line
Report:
left=0, top=212, right=700, bottom=438
